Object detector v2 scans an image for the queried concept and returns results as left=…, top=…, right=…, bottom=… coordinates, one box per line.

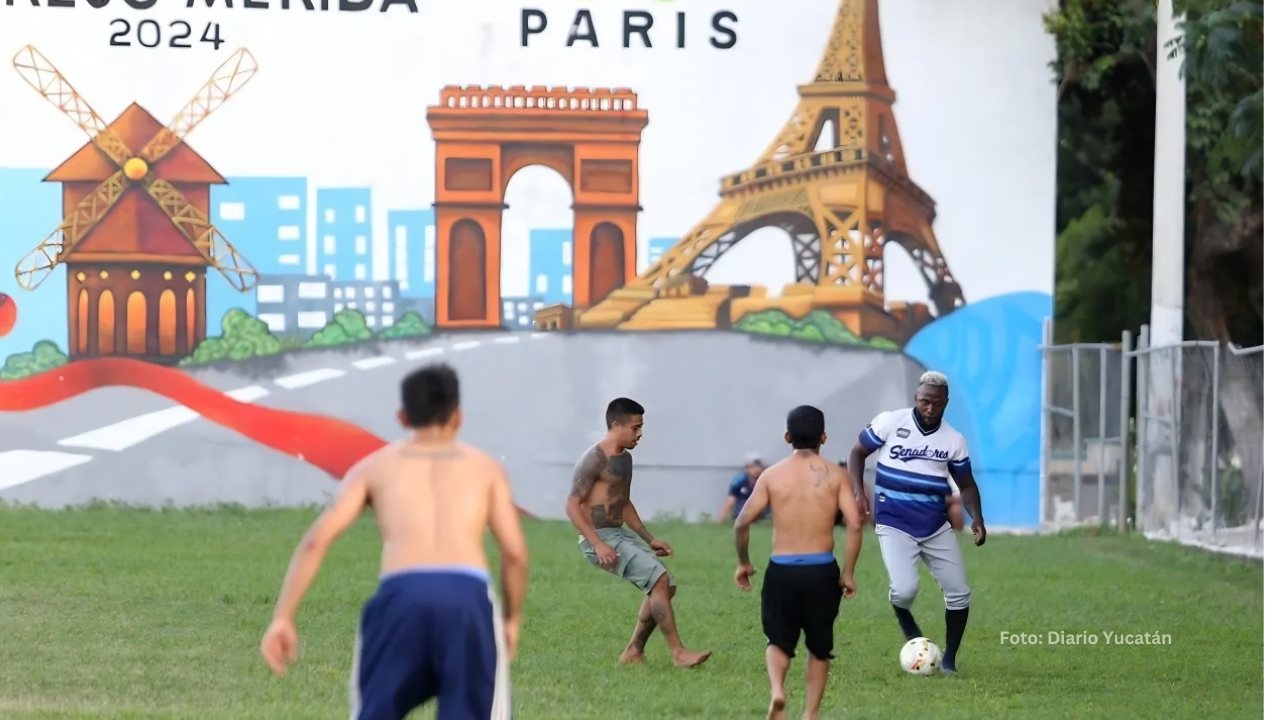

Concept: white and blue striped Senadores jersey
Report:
left=858, top=407, right=969, bottom=538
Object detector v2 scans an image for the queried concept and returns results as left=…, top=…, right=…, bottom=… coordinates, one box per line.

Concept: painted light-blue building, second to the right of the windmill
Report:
left=316, top=187, right=374, bottom=281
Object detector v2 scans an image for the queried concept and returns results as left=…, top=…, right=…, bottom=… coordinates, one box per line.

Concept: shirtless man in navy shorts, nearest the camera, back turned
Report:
left=261, top=365, right=529, bottom=720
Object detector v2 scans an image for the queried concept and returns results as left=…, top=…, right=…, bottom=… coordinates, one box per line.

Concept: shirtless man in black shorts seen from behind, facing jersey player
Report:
left=733, top=405, right=863, bottom=720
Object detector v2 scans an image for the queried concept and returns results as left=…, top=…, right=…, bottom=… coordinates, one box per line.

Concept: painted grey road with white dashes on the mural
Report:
left=0, top=332, right=922, bottom=518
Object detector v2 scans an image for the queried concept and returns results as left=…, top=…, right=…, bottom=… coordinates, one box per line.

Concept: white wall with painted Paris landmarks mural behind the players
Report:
left=0, top=0, right=1056, bottom=527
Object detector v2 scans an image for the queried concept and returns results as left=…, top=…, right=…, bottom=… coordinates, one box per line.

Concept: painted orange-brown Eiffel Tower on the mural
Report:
left=565, top=0, right=964, bottom=342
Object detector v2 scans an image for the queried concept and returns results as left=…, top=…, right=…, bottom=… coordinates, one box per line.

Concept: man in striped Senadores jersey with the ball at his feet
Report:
left=849, top=372, right=987, bottom=673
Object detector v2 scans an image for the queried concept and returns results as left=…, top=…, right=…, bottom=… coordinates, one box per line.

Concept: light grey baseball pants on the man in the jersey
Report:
left=876, top=517, right=969, bottom=610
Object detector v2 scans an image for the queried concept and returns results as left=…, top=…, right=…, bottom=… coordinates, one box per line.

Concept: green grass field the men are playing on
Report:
left=0, top=509, right=1263, bottom=720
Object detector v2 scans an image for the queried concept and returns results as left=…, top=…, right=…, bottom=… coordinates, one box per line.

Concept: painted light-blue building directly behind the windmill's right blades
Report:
left=206, top=177, right=308, bottom=336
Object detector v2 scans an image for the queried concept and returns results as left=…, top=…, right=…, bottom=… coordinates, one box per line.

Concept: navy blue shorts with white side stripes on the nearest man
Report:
left=351, top=568, right=511, bottom=720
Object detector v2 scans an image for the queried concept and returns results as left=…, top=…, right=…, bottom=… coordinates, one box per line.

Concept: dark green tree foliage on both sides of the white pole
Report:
left=1044, top=0, right=1262, bottom=345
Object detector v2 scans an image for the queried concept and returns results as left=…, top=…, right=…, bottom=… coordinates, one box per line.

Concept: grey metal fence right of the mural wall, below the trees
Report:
left=1041, top=324, right=1262, bottom=556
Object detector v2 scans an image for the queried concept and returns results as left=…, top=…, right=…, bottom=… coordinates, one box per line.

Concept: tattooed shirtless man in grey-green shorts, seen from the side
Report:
left=564, top=397, right=712, bottom=667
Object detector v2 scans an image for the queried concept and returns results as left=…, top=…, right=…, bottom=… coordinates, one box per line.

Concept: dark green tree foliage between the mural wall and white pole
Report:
left=1044, top=0, right=1156, bottom=342
